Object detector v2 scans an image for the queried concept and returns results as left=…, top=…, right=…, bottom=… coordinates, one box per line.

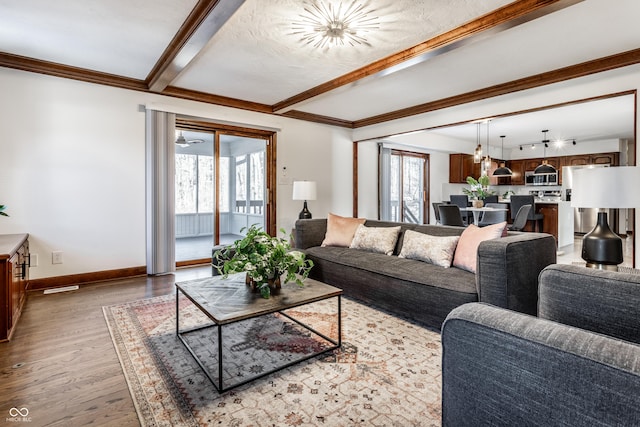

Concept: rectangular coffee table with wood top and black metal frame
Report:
left=176, top=273, right=342, bottom=393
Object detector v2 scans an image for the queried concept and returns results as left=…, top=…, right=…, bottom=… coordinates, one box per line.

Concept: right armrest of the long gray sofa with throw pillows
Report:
left=476, top=233, right=556, bottom=315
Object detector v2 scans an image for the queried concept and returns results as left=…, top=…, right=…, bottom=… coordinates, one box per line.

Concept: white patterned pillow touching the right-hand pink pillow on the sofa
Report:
left=398, top=230, right=460, bottom=268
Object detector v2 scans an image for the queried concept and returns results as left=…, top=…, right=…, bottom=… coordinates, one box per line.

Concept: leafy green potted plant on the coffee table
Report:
left=215, top=224, right=313, bottom=298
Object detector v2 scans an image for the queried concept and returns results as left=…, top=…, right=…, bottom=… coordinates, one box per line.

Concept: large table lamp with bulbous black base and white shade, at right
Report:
left=571, top=166, right=640, bottom=271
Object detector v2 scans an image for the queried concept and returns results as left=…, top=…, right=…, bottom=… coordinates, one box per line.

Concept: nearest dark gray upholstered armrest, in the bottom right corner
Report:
left=442, top=303, right=640, bottom=427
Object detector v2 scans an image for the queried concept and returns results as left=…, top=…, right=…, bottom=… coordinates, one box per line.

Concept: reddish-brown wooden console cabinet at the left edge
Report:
left=0, top=234, right=29, bottom=342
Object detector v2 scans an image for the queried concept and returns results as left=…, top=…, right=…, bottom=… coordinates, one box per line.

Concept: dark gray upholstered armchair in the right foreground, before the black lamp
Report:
left=442, top=264, right=640, bottom=426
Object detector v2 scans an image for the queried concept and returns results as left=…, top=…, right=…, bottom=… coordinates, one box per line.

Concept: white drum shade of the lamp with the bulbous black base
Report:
left=571, top=166, right=640, bottom=209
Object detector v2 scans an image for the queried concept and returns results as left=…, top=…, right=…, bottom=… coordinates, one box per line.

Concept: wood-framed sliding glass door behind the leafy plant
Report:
left=175, top=119, right=276, bottom=267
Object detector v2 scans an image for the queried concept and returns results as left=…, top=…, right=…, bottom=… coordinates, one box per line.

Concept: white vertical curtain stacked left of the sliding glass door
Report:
left=145, top=109, right=176, bottom=275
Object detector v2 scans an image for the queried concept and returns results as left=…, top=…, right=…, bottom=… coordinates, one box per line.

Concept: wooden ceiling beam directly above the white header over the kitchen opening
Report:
left=354, top=49, right=640, bottom=128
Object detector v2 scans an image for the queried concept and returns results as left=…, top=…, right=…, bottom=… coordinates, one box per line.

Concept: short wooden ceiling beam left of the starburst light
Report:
left=145, top=0, right=245, bottom=92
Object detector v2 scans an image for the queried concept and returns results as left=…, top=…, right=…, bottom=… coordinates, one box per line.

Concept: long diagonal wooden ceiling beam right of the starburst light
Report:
left=273, top=0, right=584, bottom=113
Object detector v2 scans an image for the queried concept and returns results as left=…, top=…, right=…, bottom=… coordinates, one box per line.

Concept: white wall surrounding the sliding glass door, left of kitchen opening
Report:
left=0, top=68, right=352, bottom=279
